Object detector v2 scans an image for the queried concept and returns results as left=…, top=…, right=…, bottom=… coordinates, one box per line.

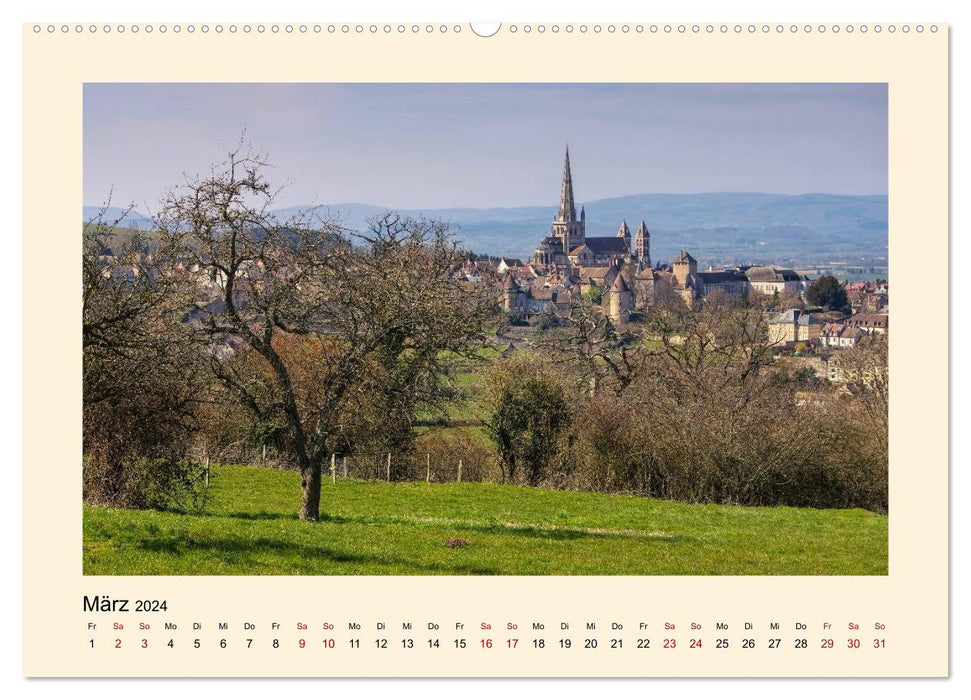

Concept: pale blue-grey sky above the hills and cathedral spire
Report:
left=84, top=83, right=887, bottom=211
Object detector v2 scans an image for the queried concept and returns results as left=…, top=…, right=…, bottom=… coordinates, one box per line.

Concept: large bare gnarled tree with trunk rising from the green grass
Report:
left=156, top=150, right=489, bottom=521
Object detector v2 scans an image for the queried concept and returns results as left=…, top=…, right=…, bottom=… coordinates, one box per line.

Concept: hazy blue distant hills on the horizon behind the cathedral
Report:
left=85, top=192, right=888, bottom=264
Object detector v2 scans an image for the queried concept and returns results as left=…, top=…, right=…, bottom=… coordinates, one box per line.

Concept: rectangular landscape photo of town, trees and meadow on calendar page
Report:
left=79, top=83, right=890, bottom=576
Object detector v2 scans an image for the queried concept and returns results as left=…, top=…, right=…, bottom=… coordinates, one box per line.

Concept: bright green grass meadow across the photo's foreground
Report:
left=84, top=467, right=887, bottom=575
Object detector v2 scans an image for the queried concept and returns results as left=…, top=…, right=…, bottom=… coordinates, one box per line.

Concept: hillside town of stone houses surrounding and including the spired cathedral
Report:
left=460, top=148, right=889, bottom=382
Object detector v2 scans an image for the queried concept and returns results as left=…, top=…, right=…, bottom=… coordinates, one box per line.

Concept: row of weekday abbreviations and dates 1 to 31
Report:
left=85, top=619, right=888, bottom=655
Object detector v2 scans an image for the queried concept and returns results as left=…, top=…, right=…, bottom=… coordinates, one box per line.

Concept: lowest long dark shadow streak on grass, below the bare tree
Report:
left=137, top=534, right=500, bottom=576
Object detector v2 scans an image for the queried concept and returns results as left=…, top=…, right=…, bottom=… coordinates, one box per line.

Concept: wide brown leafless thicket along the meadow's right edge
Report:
left=555, top=348, right=888, bottom=512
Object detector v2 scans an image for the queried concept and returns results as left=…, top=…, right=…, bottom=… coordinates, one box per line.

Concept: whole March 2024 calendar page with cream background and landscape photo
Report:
left=23, top=21, right=949, bottom=677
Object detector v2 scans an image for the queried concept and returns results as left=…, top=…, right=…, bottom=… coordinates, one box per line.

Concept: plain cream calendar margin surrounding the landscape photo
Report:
left=23, top=24, right=948, bottom=676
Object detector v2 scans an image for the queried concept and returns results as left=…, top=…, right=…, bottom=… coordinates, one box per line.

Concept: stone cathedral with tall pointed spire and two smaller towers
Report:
left=533, top=146, right=651, bottom=267
